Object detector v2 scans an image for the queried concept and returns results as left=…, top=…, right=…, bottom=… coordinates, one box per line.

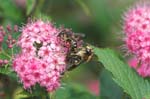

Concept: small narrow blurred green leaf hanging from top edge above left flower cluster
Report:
left=26, top=0, right=36, bottom=15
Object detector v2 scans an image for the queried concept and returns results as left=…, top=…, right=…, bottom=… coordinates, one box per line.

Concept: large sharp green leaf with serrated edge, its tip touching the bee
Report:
left=94, top=47, right=150, bottom=99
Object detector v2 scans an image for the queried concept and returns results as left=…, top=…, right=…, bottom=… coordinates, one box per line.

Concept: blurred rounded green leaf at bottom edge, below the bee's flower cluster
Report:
left=54, top=83, right=96, bottom=99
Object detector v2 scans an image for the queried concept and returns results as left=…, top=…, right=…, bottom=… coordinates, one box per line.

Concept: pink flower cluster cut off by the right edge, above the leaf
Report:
left=124, top=4, right=150, bottom=77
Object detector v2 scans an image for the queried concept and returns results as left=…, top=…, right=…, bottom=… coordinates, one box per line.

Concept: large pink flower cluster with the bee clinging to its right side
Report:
left=13, top=20, right=67, bottom=92
